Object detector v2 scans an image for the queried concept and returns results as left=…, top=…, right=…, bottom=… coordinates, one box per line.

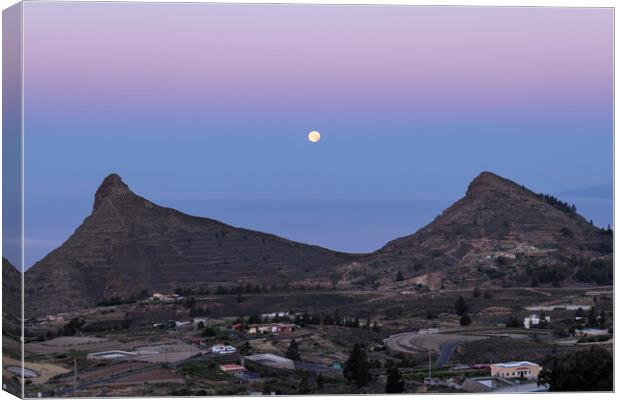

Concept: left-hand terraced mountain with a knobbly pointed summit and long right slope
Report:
left=26, top=174, right=356, bottom=316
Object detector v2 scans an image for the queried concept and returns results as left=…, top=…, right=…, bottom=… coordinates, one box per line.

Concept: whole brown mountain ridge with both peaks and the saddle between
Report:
left=26, top=171, right=613, bottom=315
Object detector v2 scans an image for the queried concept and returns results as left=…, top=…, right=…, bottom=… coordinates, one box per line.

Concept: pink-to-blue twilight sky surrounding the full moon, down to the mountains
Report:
left=9, top=2, right=613, bottom=268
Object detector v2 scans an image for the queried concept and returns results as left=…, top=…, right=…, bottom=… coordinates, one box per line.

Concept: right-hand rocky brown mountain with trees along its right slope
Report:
left=360, top=172, right=613, bottom=286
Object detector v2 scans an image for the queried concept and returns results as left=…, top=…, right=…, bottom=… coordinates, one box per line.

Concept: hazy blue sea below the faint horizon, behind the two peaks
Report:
left=25, top=197, right=613, bottom=267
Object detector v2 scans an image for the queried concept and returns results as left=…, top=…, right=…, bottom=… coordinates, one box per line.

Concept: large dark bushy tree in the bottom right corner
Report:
left=538, top=346, right=613, bottom=392
